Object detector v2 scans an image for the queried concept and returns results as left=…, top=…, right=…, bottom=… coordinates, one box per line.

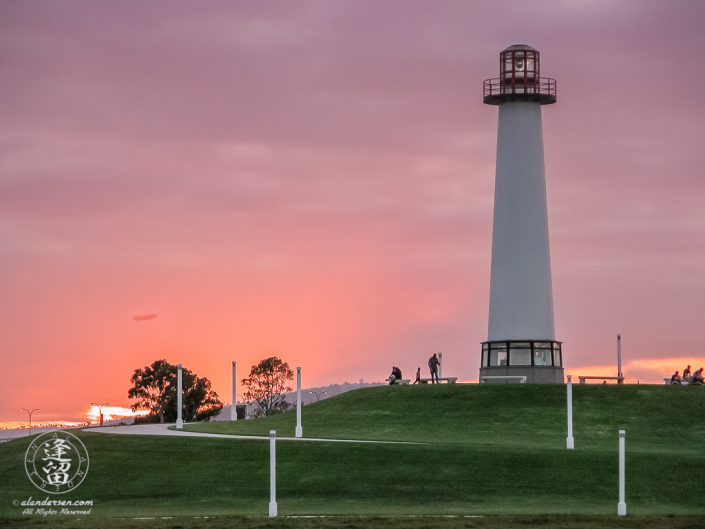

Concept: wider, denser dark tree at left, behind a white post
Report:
left=127, top=360, right=223, bottom=423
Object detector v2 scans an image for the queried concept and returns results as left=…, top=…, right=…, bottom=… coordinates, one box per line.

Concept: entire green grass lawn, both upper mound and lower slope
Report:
left=0, top=384, right=705, bottom=516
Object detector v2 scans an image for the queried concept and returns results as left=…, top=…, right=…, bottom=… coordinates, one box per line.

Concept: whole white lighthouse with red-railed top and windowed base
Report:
left=480, top=44, right=563, bottom=383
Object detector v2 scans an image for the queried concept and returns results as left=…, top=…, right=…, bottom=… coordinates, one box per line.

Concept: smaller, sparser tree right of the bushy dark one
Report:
left=241, top=356, right=294, bottom=417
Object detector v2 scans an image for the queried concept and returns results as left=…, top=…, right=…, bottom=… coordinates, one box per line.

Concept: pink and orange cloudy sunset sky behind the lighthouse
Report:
left=0, top=0, right=705, bottom=425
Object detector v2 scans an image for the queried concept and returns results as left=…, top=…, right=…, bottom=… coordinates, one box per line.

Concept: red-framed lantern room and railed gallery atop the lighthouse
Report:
left=483, top=44, right=556, bottom=105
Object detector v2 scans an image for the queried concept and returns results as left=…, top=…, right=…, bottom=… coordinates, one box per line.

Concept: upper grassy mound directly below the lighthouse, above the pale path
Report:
left=186, top=384, right=705, bottom=448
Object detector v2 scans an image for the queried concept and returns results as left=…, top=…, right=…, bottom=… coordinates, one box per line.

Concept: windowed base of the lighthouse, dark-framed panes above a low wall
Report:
left=480, top=340, right=563, bottom=384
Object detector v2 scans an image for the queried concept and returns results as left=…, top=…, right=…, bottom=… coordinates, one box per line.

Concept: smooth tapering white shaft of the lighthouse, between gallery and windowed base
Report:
left=488, top=101, right=555, bottom=341
